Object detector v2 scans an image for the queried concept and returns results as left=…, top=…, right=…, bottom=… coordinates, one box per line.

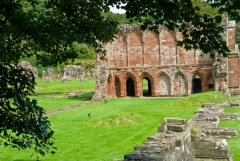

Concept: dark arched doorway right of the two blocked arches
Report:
left=192, top=71, right=203, bottom=94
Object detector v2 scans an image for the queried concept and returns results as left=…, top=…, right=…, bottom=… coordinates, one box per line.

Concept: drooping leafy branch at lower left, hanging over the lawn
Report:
left=0, top=64, right=55, bottom=156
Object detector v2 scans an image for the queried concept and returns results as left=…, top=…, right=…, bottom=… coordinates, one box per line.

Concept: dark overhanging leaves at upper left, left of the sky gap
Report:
left=0, top=0, right=117, bottom=64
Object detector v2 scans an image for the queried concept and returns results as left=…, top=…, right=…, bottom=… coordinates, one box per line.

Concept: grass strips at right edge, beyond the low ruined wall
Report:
left=219, top=108, right=240, bottom=161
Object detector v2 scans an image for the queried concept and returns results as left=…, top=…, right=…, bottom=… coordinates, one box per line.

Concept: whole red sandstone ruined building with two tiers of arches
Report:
left=94, top=21, right=239, bottom=99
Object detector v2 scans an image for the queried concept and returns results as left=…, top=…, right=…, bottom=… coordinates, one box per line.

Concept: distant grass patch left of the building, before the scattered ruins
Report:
left=30, top=79, right=95, bottom=111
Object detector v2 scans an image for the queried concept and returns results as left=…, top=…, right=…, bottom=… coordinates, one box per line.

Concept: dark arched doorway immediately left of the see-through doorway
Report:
left=124, top=72, right=137, bottom=96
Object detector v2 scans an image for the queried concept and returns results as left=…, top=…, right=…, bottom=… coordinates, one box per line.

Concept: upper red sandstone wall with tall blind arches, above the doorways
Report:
left=103, top=29, right=213, bottom=68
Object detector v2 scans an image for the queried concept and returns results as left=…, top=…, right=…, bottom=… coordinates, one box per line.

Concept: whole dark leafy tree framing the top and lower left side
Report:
left=0, top=0, right=240, bottom=155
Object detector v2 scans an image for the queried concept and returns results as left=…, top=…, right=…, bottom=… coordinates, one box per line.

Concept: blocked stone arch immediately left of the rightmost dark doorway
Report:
left=174, top=71, right=188, bottom=96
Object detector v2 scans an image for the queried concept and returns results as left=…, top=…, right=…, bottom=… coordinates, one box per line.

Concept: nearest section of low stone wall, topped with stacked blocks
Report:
left=124, top=118, right=194, bottom=161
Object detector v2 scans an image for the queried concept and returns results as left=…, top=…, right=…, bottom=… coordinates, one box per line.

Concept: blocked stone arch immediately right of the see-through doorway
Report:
left=159, top=72, right=171, bottom=95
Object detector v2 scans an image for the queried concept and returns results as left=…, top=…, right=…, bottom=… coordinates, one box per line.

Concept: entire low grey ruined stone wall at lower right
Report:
left=120, top=104, right=239, bottom=161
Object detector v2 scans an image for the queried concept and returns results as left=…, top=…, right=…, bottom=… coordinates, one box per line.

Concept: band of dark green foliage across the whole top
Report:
left=0, top=0, right=240, bottom=64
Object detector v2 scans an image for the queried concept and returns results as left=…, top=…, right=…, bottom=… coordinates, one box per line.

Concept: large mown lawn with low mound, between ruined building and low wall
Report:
left=0, top=92, right=229, bottom=161
